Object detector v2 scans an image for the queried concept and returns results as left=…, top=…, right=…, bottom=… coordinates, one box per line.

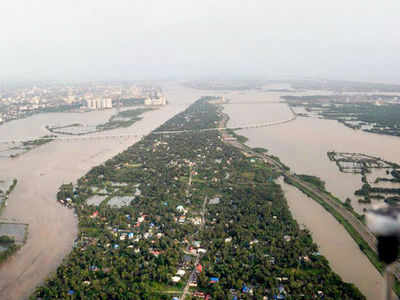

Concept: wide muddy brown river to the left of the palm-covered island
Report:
left=0, top=85, right=202, bottom=299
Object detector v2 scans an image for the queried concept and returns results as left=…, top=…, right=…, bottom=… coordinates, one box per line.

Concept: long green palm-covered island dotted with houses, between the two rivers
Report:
left=32, top=98, right=365, bottom=299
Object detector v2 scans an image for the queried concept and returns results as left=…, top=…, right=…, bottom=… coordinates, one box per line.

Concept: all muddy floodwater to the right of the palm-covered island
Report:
left=224, top=91, right=400, bottom=299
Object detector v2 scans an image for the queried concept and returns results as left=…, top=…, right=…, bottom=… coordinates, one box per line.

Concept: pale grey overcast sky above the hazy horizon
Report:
left=0, top=0, right=400, bottom=83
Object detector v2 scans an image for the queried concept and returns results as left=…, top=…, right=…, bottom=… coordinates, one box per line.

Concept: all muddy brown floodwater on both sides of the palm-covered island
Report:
left=0, top=85, right=400, bottom=299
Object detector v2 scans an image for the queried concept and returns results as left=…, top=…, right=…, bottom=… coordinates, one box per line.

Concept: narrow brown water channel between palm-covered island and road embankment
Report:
left=280, top=180, right=384, bottom=299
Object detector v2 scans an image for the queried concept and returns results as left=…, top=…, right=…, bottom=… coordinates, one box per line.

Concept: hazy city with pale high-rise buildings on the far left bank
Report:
left=0, top=82, right=166, bottom=124
